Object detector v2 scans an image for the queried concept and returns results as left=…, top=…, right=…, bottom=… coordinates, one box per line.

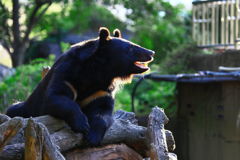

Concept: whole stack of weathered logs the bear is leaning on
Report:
left=0, top=107, right=177, bottom=160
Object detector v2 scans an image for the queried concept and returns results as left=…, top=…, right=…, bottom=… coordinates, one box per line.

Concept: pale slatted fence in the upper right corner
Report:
left=192, top=0, right=240, bottom=49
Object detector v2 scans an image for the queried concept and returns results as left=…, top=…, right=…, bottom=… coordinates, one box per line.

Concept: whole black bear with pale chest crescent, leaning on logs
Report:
left=7, top=27, right=154, bottom=145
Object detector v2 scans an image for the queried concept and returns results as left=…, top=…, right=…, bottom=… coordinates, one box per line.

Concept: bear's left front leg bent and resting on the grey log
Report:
left=45, top=95, right=90, bottom=135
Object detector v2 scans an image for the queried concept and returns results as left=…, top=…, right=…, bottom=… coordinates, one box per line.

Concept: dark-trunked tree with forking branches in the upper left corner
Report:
left=0, top=0, right=54, bottom=67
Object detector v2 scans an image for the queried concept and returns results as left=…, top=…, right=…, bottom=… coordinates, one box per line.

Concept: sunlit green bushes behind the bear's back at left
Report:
left=0, top=56, right=54, bottom=111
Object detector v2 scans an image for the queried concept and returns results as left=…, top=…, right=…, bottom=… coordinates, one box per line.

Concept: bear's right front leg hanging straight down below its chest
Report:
left=84, top=97, right=114, bottom=146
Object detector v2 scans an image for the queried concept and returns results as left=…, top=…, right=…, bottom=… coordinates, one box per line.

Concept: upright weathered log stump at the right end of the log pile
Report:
left=148, top=107, right=177, bottom=160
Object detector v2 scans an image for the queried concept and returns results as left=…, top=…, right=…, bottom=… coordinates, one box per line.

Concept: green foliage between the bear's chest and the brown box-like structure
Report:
left=115, top=80, right=176, bottom=116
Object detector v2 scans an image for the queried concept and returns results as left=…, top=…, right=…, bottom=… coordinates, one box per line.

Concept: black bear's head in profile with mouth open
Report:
left=99, top=28, right=154, bottom=76
